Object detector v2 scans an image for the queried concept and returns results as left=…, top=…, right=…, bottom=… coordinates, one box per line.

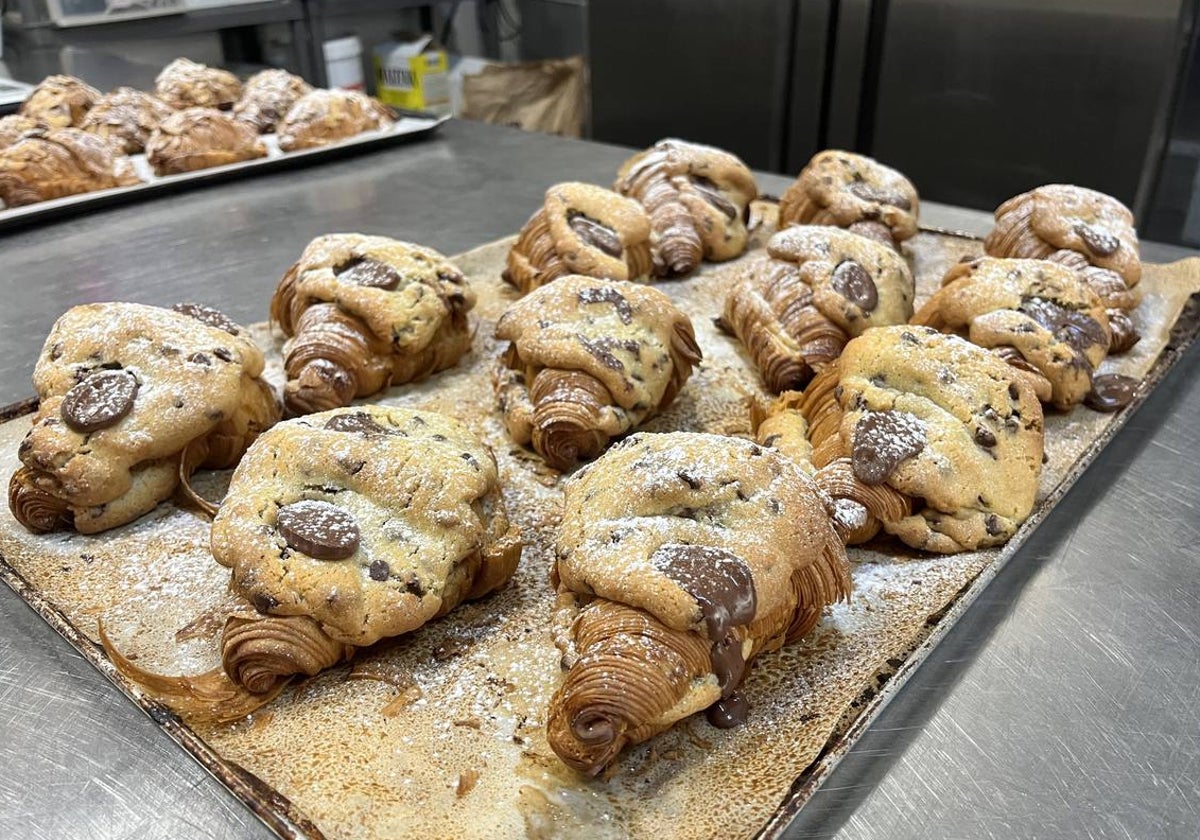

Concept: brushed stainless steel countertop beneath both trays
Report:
left=0, top=122, right=1200, bottom=840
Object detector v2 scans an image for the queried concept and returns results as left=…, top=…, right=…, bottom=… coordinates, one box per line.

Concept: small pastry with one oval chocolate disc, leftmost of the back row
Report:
left=504, top=181, right=652, bottom=293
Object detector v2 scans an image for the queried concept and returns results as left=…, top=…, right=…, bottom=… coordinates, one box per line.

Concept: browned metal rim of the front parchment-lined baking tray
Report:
left=0, top=264, right=1200, bottom=840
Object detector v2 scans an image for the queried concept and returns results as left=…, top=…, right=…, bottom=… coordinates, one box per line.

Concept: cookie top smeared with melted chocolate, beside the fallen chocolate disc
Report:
left=913, top=257, right=1111, bottom=409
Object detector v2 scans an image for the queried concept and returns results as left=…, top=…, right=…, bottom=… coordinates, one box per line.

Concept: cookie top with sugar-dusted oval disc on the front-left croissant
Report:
left=211, top=406, right=521, bottom=646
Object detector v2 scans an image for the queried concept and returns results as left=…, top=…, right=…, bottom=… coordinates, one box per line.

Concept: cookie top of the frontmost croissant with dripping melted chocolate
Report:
left=556, top=432, right=848, bottom=641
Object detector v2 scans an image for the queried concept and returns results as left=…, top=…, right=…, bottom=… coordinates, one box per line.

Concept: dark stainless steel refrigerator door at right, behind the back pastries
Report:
left=859, top=0, right=1184, bottom=209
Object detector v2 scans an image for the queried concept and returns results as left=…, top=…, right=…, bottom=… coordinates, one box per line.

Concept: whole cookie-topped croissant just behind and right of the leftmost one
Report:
left=271, top=233, right=475, bottom=414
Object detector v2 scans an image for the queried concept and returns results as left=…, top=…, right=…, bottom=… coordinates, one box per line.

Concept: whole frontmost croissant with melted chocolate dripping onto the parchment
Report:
left=546, top=432, right=851, bottom=775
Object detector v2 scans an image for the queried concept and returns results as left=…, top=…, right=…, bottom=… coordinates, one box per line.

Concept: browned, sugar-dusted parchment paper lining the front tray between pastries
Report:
left=0, top=223, right=1200, bottom=839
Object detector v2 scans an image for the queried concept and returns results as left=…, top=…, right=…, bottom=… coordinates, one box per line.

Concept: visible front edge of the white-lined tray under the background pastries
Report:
left=0, top=112, right=450, bottom=233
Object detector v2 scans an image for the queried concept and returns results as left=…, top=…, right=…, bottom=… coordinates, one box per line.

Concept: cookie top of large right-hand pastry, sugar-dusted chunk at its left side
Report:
left=808, top=326, right=1043, bottom=553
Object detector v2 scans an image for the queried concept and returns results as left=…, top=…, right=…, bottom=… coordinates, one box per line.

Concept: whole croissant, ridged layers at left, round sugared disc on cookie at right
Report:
left=720, top=226, right=913, bottom=392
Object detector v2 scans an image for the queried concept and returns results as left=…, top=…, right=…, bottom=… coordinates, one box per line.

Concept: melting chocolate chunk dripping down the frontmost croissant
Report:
left=650, top=542, right=758, bottom=642
